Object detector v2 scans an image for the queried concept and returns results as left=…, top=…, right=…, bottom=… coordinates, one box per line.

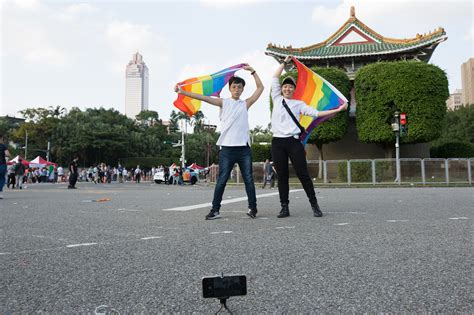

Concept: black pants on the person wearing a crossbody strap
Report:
left=272, top=137, right=316, bottom=204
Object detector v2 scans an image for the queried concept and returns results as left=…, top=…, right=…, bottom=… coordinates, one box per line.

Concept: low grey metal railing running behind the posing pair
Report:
left=209, top=158, right=474, bottom=186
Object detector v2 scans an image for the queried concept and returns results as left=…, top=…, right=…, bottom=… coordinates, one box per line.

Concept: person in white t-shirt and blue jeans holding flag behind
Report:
left=175, top=64, right=263, bottom=220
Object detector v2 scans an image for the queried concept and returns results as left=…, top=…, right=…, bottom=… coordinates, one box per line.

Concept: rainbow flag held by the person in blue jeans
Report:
left=173, top=64, right=245, bottom=117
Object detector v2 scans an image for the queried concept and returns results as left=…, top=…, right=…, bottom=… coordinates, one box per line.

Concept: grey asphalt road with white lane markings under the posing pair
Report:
left=0, top=183, right=474, bottom=314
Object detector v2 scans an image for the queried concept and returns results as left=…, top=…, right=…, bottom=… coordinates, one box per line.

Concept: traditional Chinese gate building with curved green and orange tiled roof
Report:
left=265, top=7, right=447, bottom=159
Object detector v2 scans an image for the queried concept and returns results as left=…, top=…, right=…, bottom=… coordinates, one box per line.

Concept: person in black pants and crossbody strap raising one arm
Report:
left=271, top=56, right=347, bottom=218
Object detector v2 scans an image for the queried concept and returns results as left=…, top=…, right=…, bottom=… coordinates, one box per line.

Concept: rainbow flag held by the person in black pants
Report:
left=291, top=57, right=348, bottom=144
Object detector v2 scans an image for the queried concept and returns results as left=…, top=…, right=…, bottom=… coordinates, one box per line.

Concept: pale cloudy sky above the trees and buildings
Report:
left=0, top=0, right=474, bottom=128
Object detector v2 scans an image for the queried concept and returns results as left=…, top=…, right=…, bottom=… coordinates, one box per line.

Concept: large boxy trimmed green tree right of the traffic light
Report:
left=355, top=61, right=449, bottom=157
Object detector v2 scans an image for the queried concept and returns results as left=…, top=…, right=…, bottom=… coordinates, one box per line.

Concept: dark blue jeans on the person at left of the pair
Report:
left=212, top=146, right=257, bottom=211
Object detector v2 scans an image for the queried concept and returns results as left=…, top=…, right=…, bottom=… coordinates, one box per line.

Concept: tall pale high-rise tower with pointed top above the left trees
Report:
left=125, top=52, right=148, bottom=119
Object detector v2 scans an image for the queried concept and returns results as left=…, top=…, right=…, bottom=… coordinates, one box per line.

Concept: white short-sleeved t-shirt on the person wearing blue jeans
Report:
left=217, top=98, right=250, bottom=147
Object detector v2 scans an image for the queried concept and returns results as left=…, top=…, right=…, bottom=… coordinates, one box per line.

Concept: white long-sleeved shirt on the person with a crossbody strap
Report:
left=271, top=78, right=319, bottom=138
